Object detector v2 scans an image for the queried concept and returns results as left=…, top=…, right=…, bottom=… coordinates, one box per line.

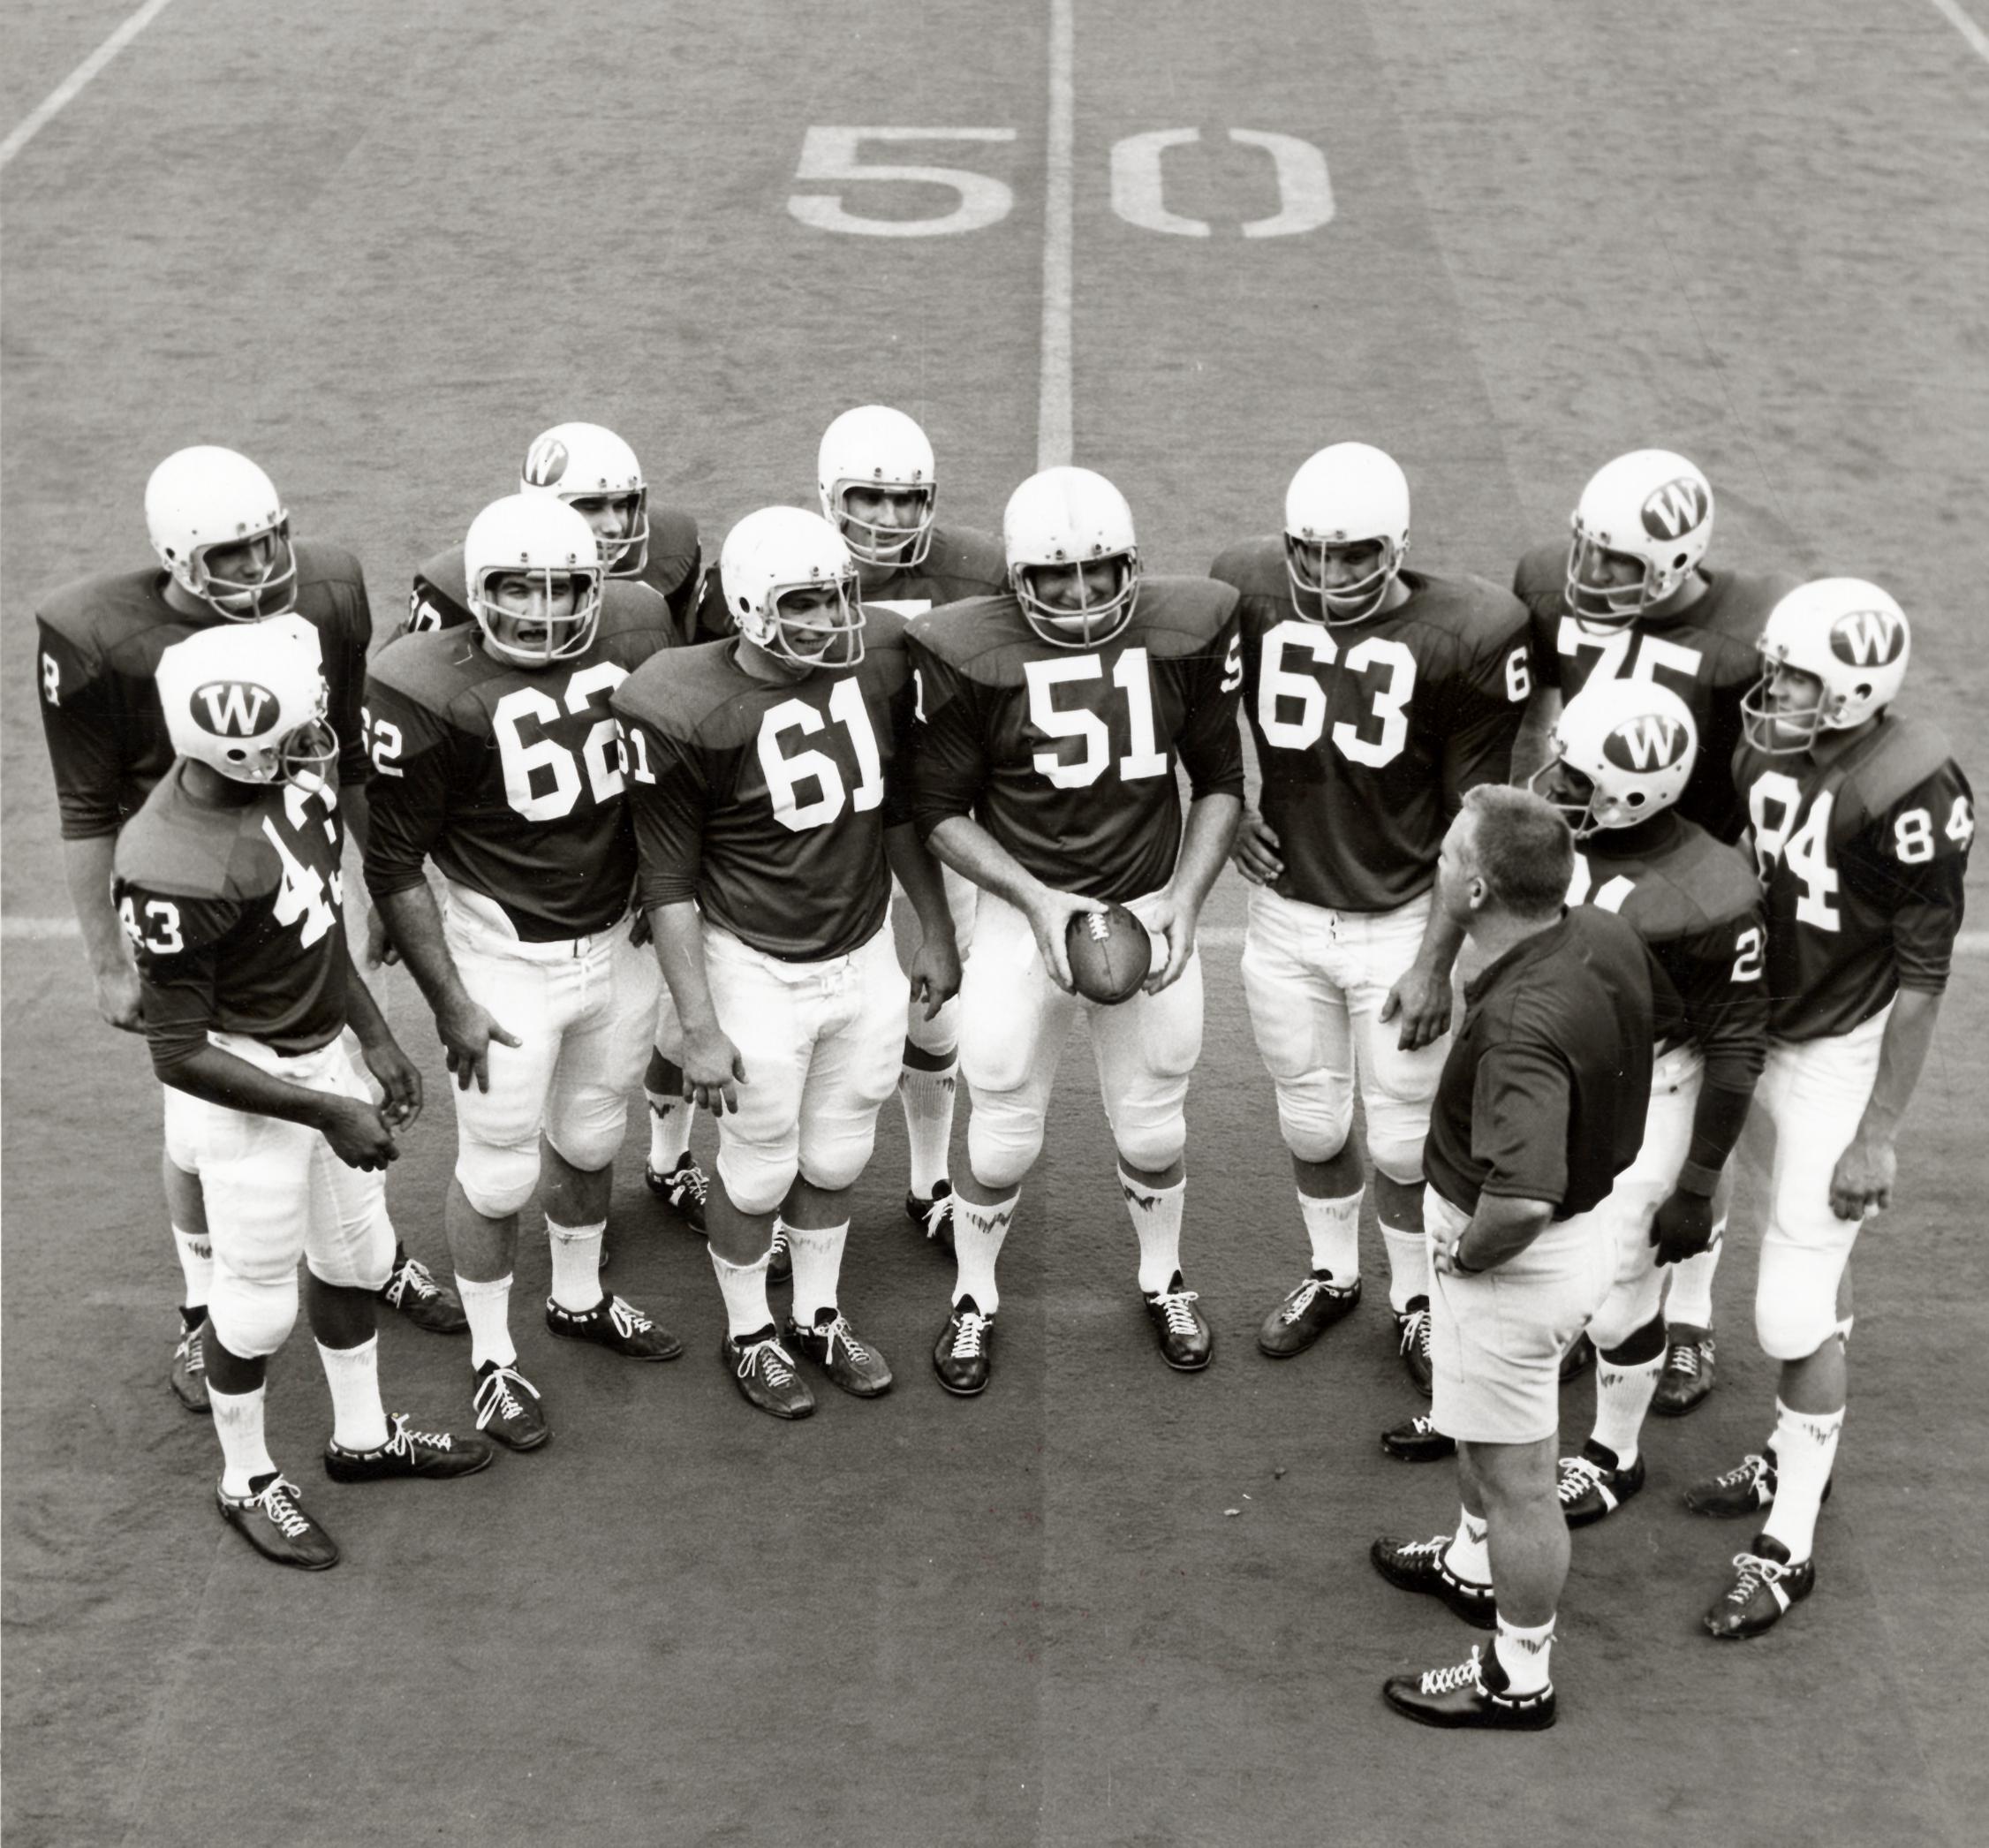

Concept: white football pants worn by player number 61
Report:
left=704, top=923, right=905, bottom=1214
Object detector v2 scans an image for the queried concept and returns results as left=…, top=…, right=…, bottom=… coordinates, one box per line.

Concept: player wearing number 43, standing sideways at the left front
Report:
left=105, top=612, right=491, bottom=1572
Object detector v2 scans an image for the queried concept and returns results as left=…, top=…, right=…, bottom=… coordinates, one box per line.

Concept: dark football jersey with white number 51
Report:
left=907, top=577, right=1244, bottom=901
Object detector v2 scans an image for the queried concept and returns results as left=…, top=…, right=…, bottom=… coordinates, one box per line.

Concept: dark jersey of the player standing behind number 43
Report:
left=36, top=539, right=372, bottom=842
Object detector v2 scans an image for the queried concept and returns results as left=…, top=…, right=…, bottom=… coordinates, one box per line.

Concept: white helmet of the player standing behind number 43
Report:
left=145, top=443, right=297, bottom=623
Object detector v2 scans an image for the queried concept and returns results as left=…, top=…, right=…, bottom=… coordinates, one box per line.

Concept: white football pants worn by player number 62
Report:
left=443, top=883, right=662, bottom=1219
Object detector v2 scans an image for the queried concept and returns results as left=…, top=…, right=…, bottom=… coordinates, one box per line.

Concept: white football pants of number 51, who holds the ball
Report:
left=961, top=891, right=1201, bottom=1190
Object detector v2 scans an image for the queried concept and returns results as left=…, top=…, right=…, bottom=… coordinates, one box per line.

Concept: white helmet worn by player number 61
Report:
left=718, top=507, right=863, bottom=669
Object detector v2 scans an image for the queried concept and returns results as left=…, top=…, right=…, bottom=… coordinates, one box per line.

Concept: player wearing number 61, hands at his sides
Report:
left=615, top=507, right=958, bottom=1419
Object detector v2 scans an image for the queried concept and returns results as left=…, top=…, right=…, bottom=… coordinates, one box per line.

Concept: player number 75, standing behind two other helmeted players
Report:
left=1512, top=450, right=1796, bottom=1416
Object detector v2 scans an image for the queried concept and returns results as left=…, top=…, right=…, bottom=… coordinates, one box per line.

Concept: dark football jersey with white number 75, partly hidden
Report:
left=1512, top=545, right=1796, bottom=842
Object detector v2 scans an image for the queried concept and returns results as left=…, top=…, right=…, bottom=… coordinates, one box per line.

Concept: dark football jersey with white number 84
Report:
left=1735, top=718, right=1975, bottom=1041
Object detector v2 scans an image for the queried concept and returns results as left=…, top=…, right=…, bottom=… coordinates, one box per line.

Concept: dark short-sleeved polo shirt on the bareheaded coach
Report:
left=1422, top=905, right=1652, bottom=1219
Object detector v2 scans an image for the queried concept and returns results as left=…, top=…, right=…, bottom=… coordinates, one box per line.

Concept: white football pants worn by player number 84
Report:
left=1741, top=1006, right=1892, bottom=1360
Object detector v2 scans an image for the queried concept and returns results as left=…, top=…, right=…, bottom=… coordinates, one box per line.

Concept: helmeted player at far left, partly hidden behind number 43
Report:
left=36, top=443, right=464, bottom=1413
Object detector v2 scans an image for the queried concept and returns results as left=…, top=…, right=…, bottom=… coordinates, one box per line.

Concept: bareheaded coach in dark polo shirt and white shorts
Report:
left=1373, top=785, right=1663, bottom=1731
